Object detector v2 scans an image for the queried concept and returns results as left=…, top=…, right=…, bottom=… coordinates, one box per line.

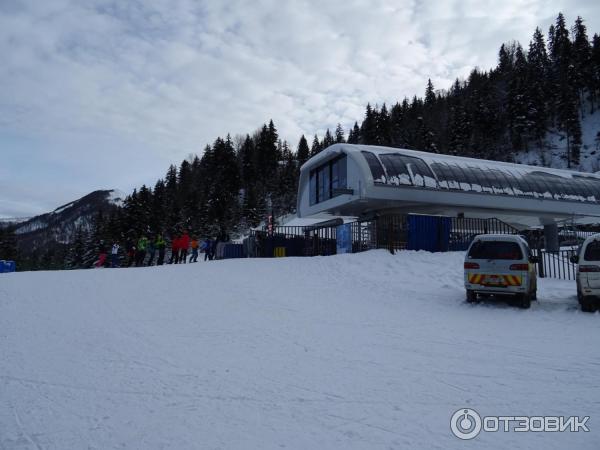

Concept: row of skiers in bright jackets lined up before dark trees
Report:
left=95, top=231, right=216, bottom=267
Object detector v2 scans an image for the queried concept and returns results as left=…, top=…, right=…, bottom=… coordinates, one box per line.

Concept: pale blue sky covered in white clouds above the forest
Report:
left=0, top=0, right=600, bottom=217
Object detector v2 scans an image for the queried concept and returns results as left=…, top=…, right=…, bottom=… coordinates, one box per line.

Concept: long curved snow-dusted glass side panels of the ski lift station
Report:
left=362, top=151, right=600, bottom=203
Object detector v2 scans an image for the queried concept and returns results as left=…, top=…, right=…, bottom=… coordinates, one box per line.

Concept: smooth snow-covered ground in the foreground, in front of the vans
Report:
left=0, top=251, right=600, bottom=450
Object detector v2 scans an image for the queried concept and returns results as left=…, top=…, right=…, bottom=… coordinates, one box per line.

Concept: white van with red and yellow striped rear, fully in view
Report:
left=464, top=234, right=537, bottom=308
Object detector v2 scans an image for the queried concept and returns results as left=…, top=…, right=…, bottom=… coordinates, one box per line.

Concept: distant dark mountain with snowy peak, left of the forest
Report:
left=15, top=190, right=125, bottom=252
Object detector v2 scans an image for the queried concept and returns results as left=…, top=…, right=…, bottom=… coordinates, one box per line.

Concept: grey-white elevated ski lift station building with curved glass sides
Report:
left=297, top=144, right=600, bottom=234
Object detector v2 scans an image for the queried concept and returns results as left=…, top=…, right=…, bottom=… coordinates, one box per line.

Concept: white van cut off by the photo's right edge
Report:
left=571, top=234, right=600, bottom=312
